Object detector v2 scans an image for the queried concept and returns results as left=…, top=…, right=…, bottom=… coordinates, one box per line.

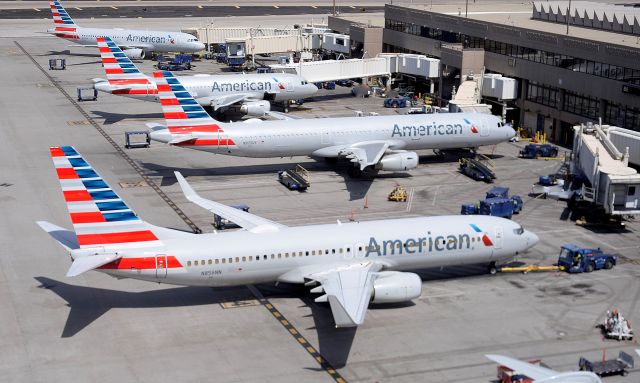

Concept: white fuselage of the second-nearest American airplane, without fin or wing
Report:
left=151, top=113, right=514, bottom=158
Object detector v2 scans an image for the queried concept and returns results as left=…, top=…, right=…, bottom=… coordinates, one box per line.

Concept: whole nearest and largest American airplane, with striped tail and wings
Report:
left=38, top=146, right=538, bottom=327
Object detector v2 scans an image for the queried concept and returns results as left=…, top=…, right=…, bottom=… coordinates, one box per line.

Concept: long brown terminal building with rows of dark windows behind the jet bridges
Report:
left=329, top=1, right=640, bottom=146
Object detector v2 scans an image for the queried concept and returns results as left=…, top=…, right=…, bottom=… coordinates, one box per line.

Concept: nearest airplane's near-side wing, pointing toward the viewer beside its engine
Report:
left=307, top=261, right=382, bottom=327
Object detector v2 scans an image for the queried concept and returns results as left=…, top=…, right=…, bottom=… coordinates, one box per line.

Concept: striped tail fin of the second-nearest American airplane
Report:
left=153, top=71, right=233, bottom=138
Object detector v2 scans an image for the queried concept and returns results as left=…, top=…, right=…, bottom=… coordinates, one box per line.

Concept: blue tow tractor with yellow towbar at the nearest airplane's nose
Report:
left=558, top=243, right=617, bottom=273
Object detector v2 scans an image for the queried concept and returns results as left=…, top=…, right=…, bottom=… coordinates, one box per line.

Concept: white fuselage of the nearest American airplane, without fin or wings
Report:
left=98, top=216, right=537, bottom=286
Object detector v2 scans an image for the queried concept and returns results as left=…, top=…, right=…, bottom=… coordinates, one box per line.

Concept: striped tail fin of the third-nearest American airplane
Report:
left=96, top=36, right=151, bottom=85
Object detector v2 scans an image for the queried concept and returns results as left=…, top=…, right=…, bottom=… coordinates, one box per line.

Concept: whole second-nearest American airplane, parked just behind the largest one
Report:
left=147, top=72, right=515, bottom=176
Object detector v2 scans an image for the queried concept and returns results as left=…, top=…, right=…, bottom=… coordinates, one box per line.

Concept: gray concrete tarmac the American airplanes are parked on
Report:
left=0, top=31, right=640, bottom=383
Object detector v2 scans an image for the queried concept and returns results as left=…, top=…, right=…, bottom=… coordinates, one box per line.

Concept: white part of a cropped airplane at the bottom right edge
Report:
left=485, top=355, right=602, bottom=383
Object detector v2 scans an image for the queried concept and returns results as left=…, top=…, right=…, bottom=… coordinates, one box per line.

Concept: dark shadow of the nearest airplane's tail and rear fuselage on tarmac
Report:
left=35, top=277, right=253, bottom=338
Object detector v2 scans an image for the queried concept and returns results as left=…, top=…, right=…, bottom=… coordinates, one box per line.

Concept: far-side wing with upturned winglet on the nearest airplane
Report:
left=174, top=172, right=286, bottom=233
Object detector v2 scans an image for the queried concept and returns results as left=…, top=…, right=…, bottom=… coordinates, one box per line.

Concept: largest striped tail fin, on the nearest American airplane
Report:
left=50, top=146, right=161, bottom=248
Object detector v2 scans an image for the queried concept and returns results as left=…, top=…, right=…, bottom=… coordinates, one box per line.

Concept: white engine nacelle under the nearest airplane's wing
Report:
left=371, top=271, right=422, bottom=303
